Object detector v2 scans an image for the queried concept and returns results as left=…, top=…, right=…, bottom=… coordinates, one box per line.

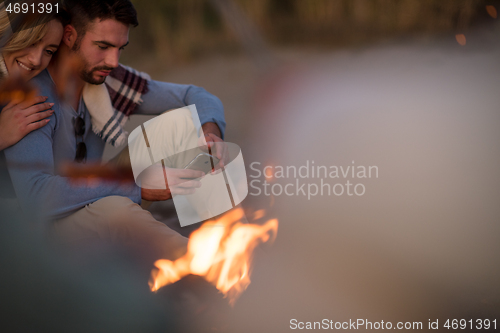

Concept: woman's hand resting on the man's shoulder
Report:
left=0, top=96, right=54, bottom=150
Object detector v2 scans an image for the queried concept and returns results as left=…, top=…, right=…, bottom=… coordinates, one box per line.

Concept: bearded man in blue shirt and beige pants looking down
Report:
left=5, top=0, right=225, bottom=258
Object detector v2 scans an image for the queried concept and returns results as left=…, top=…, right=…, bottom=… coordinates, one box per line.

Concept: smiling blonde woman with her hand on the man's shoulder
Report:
left=0, top=5, right=67, bottom=151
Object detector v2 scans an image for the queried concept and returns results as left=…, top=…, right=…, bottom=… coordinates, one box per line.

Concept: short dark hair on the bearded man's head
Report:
left=64, top=0, right=139, bottom=39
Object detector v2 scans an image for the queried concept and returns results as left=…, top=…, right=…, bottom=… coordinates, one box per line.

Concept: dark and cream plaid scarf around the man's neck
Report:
left=83, top=65, right=150, bottom=147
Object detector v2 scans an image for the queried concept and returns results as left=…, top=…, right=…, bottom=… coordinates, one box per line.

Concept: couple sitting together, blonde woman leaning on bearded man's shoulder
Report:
left=0, top=0, right=225, bottom=260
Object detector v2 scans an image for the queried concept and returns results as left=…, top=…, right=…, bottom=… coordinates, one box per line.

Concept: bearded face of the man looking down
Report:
left=72, top=19, right=129, bottom=84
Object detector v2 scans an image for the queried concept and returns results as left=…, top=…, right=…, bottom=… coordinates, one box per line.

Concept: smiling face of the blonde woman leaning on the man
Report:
left=3, top=20, right=63, bottom=81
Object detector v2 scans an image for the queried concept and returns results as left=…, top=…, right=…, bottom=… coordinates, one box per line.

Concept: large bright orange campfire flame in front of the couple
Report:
left=149, top=208, right=278, bottom=305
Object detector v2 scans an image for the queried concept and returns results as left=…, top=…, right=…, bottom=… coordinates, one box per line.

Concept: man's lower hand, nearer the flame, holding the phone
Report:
left=141, top=164, right=205, bottom=201
